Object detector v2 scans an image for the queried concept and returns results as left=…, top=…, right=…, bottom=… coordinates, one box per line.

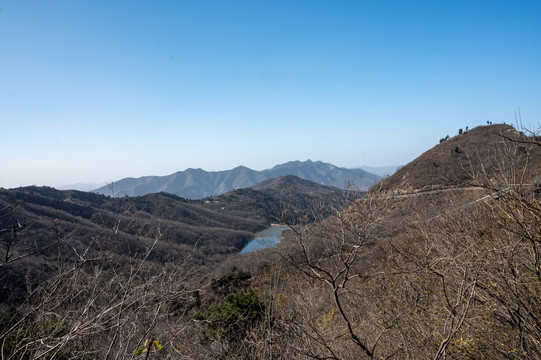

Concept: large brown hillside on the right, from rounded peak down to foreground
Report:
left=213, top=125, right=541, bottom=360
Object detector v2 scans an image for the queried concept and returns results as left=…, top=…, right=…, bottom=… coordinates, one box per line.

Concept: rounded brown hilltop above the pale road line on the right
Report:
left=377, top=124, right=541, bottom=192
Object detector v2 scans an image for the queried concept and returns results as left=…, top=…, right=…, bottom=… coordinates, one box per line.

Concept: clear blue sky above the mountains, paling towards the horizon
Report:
left=0, top=0, right=541, bottom=187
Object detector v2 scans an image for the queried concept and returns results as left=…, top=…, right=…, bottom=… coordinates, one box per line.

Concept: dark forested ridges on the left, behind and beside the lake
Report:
left=0, top=176, right=342, bottom=253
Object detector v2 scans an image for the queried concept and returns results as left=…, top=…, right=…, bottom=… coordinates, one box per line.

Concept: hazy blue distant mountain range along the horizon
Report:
left=92, top=160, right=381, bottom=199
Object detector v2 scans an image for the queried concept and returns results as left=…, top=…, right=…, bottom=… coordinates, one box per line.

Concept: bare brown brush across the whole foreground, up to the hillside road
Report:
left=0, top=127, right=541, bottom=359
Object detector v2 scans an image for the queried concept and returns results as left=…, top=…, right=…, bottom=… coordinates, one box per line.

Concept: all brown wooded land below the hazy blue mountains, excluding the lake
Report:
left=0, top=124, right=541, bottom=359
